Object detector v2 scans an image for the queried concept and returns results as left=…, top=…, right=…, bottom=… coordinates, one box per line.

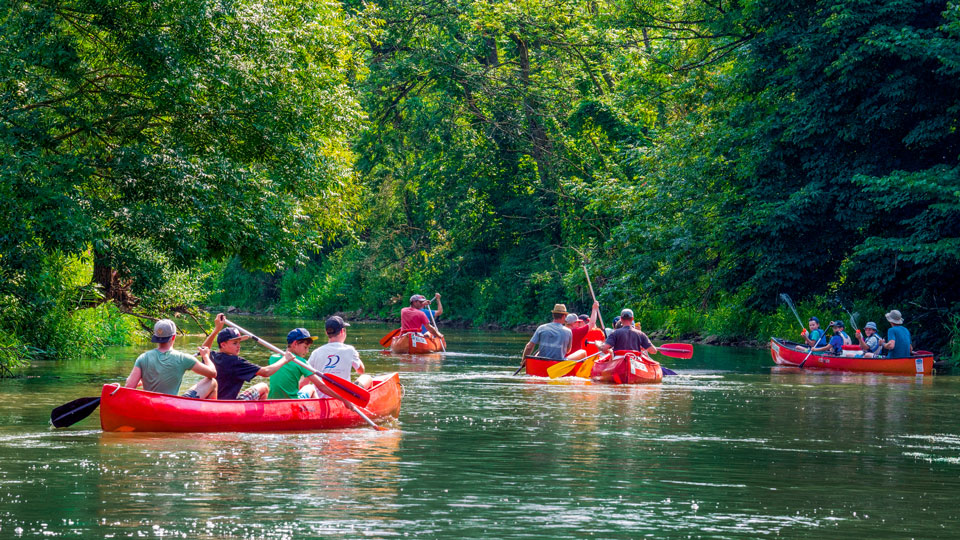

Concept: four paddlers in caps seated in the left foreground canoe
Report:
left=125, top=313, right=372, bottom=401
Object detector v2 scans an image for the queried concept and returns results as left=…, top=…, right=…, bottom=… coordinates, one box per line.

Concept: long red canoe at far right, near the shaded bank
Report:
left=770, top=338, right=933, bottom=375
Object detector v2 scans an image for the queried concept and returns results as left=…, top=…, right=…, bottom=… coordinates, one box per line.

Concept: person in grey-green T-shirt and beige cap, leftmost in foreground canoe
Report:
left=125, top=319, right=217, bottom=399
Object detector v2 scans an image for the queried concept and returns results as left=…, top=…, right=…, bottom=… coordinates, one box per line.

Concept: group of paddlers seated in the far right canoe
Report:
left=800, top=309, right=914, bottom=358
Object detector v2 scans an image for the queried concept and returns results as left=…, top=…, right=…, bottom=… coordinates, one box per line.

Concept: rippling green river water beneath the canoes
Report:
left=0, top=319, right=960, bottom=539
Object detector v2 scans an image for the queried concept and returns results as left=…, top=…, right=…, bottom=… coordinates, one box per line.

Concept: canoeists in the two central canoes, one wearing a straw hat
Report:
left=523, top=302, right=658, bottom=360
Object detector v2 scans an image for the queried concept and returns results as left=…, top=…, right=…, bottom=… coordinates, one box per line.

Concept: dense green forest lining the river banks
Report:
left=0, top=0, right=960, bottom=364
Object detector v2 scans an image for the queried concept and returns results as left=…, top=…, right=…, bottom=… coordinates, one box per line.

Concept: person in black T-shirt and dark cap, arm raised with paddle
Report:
left=203, top=313, right=293, bottom=401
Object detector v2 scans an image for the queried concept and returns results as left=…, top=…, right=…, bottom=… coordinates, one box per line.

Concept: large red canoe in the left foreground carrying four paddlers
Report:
left=100, top=373, right=403, bottom=432
